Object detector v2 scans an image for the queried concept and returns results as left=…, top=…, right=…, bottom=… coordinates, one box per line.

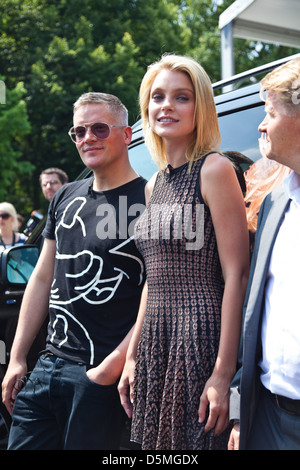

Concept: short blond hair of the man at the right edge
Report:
left=260, top=58, right=300, bottom=112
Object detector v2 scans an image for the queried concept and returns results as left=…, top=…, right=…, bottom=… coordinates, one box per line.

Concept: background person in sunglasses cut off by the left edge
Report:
left=0, top=202, right=27, bottom=252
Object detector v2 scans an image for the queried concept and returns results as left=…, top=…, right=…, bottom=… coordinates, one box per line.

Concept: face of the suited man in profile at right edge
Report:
left=258, top=92, right=300, bottom=173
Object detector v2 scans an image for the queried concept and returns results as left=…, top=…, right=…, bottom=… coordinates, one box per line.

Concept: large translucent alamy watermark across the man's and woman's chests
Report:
left=96, top=196, right=204, bottom=250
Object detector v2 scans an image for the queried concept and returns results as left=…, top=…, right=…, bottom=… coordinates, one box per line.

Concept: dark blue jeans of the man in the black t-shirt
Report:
left=8, top=354, right=124, bottom=450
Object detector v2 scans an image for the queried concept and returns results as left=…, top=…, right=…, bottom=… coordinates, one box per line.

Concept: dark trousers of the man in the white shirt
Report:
left=246, top=388, right=300, bottom=450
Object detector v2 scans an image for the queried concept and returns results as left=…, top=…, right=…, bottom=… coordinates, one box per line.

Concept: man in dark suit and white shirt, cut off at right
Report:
left=228, top=59, right=300, bottom=450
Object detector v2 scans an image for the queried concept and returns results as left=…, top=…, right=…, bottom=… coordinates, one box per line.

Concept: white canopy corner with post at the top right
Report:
left=219, top=0, right=300, bottom=78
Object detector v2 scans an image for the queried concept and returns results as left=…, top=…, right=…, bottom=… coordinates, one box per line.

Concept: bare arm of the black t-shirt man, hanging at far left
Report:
left=2, top=239, right=55, bottom=413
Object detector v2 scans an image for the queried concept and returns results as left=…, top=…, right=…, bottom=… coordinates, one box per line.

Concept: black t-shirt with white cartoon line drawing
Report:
left=43, top=177, right=146, bottom=365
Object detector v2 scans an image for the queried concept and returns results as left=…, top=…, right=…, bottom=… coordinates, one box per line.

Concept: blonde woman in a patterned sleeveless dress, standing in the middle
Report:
left=119, top=55, right=249, bottom=450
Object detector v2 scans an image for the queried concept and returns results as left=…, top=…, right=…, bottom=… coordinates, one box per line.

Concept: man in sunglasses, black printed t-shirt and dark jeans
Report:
left=3, top=93, right=146, bottom=450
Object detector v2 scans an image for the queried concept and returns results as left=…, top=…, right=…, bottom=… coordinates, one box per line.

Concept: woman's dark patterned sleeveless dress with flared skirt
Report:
left=131, top=154, right=228, bottom=450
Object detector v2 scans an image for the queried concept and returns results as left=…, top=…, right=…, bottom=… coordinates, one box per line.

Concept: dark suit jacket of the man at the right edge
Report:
left=230, top=187, right=290, bottom=449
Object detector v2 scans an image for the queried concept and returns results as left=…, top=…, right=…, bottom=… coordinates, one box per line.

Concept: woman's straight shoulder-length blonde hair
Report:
left=139, top=54, right=221, bottom=168
